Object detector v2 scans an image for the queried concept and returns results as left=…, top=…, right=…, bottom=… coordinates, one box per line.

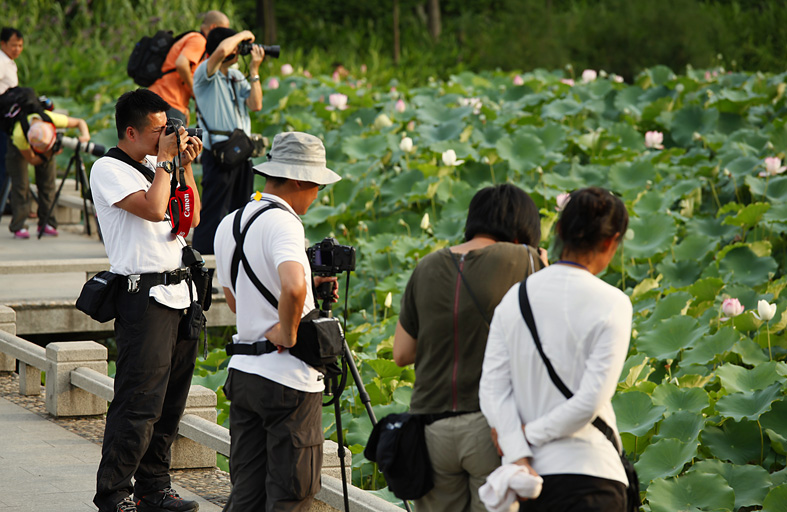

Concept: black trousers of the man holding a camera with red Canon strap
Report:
left=93, top=290, right=197, bottom=511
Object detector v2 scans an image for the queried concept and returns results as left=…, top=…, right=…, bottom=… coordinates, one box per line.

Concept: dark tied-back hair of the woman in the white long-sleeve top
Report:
left=557, top=187, right=629, bottom=253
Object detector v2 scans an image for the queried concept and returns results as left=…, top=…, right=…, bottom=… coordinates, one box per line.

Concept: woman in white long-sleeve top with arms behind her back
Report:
left=479, top=187, right=632, bottom=512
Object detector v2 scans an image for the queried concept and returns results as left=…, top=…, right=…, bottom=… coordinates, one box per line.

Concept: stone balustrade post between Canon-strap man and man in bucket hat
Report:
left=170, top=385, right=218, bottom=469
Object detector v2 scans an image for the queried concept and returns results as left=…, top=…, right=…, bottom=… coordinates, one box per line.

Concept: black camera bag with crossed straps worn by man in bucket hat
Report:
left=226, top=202, right=344, bottom=378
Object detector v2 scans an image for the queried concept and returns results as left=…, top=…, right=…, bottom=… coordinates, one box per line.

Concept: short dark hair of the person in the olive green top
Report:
left=465, top=183, right=541, bottom=247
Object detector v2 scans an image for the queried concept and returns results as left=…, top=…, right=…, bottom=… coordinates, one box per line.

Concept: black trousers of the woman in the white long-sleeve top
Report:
left=519, top=475, right=626, bottom=512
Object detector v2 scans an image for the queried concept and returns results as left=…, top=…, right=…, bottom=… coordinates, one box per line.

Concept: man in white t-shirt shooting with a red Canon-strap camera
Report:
left=90, top=89, right=202, bottom=512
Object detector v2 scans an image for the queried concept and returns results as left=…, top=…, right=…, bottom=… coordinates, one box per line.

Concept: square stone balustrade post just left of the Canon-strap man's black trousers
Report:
left=46, top=341, right=107, bottom=417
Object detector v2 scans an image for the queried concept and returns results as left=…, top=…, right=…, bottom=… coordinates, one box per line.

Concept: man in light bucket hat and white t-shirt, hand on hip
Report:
left=214, top=132, right=341, bottom=511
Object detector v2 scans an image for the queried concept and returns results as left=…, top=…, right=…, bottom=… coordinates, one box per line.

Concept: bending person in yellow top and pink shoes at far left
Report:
left=6, top=108, right=90, bottom=239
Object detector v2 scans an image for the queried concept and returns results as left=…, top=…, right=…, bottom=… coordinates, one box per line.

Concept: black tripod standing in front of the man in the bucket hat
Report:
left=316, top=278, right=411, bottom=512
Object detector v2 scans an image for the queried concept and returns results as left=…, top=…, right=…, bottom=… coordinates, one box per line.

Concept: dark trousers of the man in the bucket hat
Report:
left=224, top=369, right=323, bottom=512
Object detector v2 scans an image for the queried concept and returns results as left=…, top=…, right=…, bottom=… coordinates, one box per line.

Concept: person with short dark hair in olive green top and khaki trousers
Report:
left=393, top=184, right=544, bottom=512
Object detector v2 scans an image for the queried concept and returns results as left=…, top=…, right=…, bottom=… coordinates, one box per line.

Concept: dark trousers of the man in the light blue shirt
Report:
left=191, top=150, right=254, bottom=254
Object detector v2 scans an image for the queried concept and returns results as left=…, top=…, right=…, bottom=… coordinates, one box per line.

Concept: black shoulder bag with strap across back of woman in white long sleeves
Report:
left=519, top=280, right=642, bottom=512
